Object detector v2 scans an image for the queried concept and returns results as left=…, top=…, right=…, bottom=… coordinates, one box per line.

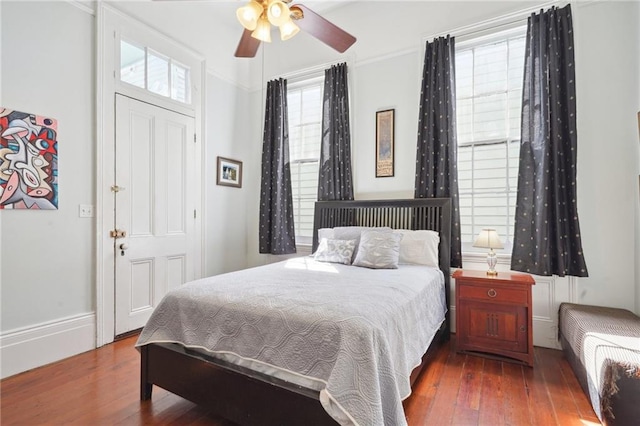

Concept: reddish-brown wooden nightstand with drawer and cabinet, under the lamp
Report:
left=453, top=269, right=535, bottom=367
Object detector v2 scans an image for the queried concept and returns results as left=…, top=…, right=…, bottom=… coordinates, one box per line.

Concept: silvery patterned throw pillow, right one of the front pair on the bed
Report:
left=353, top=229, right=402, bottom=269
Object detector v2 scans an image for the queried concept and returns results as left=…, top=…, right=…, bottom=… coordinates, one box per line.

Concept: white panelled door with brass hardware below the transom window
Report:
left=114, top=95, right=195, bottom=335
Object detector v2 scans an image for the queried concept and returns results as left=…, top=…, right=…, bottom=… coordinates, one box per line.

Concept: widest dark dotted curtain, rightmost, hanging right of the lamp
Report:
left=511, top=5, right=588, bottom=277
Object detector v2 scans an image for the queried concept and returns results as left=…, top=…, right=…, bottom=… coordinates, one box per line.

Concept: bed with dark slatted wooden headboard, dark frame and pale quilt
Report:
left=138, top=199, right=451, bottom=425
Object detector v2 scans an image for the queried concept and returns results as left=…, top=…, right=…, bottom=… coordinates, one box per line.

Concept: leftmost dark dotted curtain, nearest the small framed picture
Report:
left=259, top=78, right=296, bottom=254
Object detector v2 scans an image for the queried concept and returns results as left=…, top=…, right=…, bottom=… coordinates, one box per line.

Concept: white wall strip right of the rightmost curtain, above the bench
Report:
left=574, top=2, right=640, bottom=312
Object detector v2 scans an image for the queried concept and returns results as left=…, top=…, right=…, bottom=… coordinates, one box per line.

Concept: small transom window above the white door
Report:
left=120, top=40, right=191, bottom=104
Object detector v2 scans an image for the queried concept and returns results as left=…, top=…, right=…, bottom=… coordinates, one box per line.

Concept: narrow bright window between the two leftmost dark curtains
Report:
left=287, top=78, right=323, bottom=244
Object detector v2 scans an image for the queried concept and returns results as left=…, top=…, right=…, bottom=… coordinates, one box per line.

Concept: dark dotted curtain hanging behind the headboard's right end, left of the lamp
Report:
left=415, top=36, right=462, bottom=268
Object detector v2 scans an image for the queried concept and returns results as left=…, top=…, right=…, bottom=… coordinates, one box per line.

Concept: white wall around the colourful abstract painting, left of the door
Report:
left=0, top=1, right=95, bottom=375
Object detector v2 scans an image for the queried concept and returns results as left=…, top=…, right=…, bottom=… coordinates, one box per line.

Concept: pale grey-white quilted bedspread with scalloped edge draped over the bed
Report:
left=137, top=257, right=446, bottom=426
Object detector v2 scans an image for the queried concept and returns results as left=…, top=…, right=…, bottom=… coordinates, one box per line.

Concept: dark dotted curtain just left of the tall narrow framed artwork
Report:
left=318, top=63, right=353, bottom=201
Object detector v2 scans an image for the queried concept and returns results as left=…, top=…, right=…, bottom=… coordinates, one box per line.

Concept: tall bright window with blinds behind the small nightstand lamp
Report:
left=456, top=27, right=526, bottom=252
